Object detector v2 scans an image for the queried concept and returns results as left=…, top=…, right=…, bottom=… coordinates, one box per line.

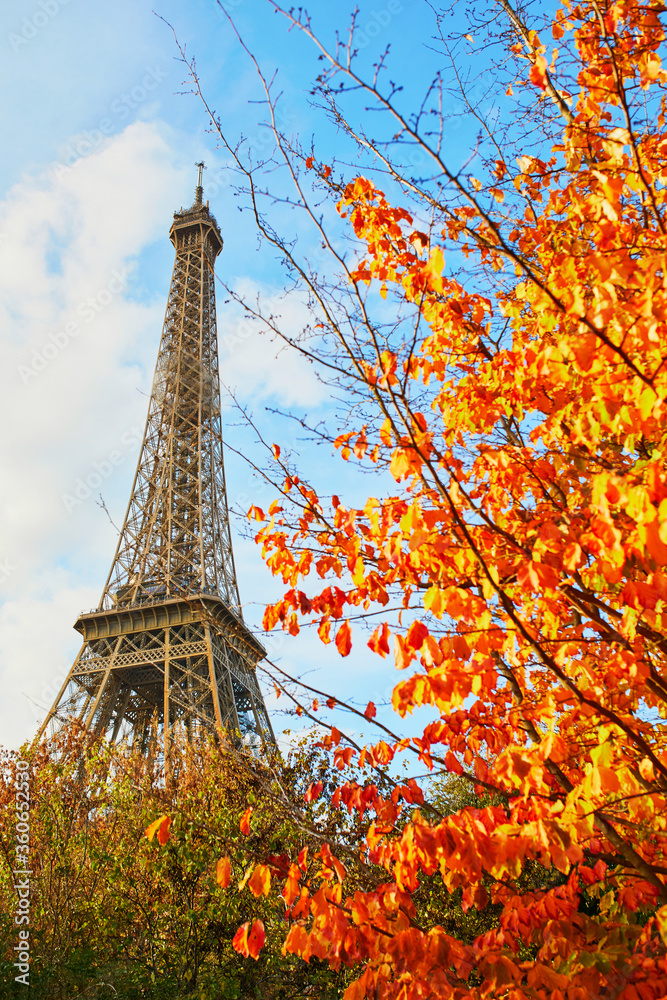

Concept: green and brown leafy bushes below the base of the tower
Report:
left=0, top=725, right=349, bottom=1000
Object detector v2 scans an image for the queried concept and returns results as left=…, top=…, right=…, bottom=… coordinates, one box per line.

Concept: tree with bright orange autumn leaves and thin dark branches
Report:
left=166, top=0, right=667, bottom=1000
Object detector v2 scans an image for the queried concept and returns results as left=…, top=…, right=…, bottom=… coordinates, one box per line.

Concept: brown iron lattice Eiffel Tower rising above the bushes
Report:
left=39, top=163, right=275, bottom=757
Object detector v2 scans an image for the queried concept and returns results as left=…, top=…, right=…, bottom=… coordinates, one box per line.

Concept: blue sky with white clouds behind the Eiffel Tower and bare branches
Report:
left=0, top=0, right=465, bottom=745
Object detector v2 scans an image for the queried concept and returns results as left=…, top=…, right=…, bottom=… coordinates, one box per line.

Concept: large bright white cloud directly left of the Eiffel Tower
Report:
left=0, top=123, right=192, bottom=743
